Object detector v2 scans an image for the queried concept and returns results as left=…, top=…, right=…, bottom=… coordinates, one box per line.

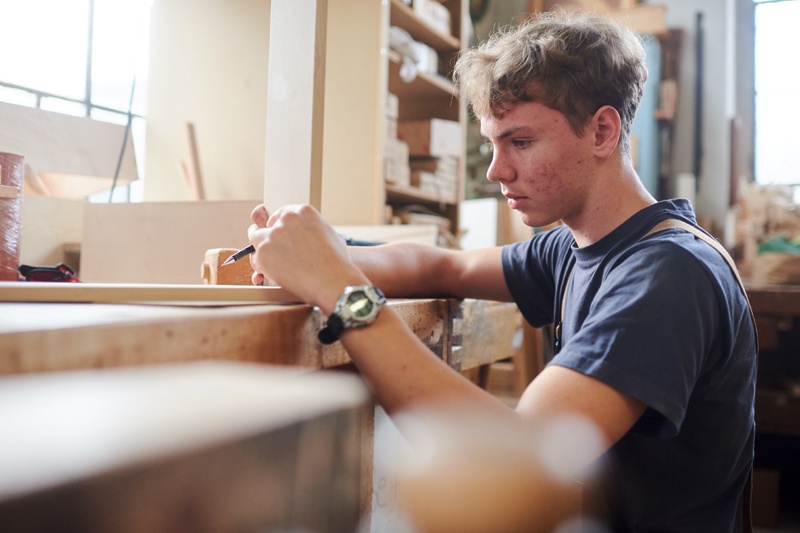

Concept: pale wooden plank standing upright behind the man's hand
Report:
left=264, top=0, right=328, bottom=213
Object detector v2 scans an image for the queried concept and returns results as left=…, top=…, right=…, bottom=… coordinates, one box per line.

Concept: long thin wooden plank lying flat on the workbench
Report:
left=0, top=281, right=298, bottom=305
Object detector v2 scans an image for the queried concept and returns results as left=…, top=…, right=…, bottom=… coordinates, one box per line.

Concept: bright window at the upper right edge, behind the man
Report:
left=755, top=0, right=800, bottom=185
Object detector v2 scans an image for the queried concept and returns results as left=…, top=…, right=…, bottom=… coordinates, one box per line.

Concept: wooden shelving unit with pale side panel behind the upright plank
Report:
left=322, top=0, right=468, bottom=245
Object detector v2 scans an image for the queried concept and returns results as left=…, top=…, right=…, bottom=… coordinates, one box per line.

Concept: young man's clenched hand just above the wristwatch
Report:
left=248, top=205, right=369, bottom=314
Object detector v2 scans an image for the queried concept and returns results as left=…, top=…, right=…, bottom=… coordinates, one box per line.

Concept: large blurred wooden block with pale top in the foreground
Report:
left=0, top=362, right=371, bottom=533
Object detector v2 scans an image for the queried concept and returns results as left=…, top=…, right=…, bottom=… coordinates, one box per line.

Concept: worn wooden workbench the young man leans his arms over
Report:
left=0, top=299, right=522, bottom=375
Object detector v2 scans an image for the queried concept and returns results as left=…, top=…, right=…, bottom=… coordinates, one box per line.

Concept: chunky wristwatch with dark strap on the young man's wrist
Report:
left=317, top=285, right=386, bottom=344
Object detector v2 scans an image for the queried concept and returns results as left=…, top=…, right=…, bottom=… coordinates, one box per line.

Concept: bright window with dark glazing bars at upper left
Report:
left=0, top=0, right=153, bottom=201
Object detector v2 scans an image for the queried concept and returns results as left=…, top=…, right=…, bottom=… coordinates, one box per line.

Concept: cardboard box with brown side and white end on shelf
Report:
left=397, top=118, right=464, bottom=157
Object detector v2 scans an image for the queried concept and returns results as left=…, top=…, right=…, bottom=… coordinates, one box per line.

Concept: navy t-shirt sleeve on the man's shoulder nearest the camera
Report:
left=552, top=242, right=719, bottom=436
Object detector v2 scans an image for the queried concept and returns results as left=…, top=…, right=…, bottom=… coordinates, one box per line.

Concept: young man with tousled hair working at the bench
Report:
left=249, top=9, right=756, bottom=532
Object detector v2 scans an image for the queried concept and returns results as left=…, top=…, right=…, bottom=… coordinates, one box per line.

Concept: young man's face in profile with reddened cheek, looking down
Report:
left=481, top=102, right=594, bottom=227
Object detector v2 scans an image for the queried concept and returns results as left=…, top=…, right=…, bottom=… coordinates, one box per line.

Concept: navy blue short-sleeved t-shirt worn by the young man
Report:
left=503, top=200, right=756, bottom=533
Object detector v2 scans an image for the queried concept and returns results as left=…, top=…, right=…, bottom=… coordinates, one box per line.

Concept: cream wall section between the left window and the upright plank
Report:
left=144, top=0, right=270, bottom=201
